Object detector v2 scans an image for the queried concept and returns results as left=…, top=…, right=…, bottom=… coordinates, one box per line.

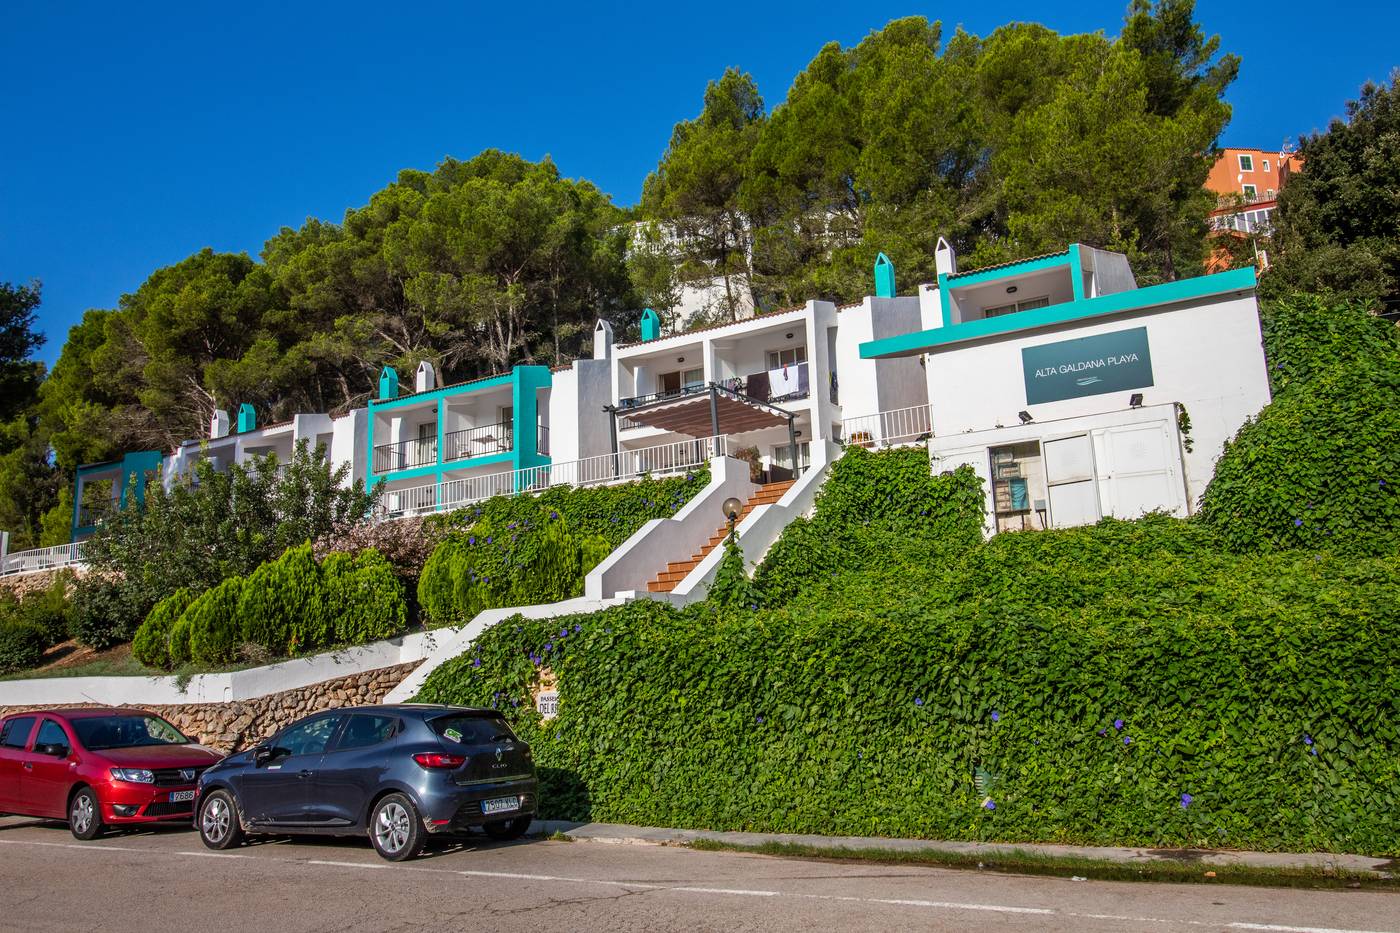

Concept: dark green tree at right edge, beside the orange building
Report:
left=1261, top=71, right=1400, bottom=310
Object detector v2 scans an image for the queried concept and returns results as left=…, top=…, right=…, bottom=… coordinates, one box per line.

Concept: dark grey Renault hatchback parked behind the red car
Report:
left=195, top=703, right=538, bottom=862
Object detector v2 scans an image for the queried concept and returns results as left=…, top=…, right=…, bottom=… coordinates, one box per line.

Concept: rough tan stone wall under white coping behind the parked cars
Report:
left=0, top=661, right=419, bottom=754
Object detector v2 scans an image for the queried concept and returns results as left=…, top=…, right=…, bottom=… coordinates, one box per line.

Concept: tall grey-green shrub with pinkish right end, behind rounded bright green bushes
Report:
left=68, top=443, right=374, bottom=646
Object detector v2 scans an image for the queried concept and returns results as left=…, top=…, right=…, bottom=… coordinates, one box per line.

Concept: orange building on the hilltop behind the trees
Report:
left=1205, top=148, right=1302, bottom=272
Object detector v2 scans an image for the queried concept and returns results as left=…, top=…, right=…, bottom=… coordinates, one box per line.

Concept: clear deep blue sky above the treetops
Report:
left=0, top=0, right=1400, bottom=361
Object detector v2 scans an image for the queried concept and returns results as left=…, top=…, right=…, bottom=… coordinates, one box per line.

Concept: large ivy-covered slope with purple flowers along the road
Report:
left=419, top=442, right=1400, bottom=853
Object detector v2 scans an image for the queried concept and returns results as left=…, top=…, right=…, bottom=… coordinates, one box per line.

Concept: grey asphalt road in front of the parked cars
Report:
left=0, top=817, right=1400, bottom=933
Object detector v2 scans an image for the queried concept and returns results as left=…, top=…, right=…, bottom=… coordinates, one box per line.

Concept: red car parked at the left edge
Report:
left=0, top=707, right=223, bottom=839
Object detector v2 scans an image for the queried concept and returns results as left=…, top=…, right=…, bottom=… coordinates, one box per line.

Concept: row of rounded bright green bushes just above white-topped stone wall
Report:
left=132, top=544, right=407, bottom=668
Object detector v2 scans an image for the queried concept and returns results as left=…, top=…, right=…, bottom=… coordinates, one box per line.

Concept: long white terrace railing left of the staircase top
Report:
left=379, top=434, right=732, bottom=520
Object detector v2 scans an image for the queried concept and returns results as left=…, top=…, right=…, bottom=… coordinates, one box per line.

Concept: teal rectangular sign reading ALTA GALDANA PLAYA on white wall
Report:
left=1021, top=328, right=1152, bottom=405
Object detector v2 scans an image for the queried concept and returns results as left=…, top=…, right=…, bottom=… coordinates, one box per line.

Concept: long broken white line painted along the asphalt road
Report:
left=0, top=839, right=1393, bottom=933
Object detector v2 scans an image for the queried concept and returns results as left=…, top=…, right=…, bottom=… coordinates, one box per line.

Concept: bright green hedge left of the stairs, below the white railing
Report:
left=419, top=469, right=710, bottom=625
